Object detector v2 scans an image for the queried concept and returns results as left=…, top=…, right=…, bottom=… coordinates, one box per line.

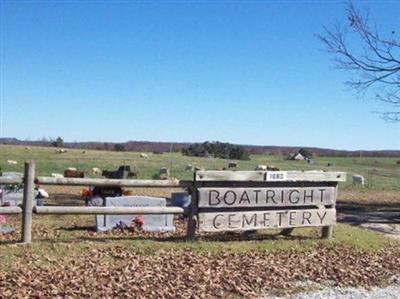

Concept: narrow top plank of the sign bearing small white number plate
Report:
left=196, top=170, right=346, bottom=182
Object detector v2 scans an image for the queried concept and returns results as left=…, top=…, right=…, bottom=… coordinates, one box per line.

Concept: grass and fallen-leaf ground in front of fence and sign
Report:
left=0, top=216, right=400, bottom=298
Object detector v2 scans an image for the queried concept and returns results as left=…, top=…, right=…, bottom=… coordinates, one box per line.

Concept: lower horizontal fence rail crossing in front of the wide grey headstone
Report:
left=33, top=206, right=184, bottom=215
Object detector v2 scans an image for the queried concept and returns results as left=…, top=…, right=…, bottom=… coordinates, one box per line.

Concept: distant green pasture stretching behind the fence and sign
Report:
left=0, top=145, right=400, bottom=190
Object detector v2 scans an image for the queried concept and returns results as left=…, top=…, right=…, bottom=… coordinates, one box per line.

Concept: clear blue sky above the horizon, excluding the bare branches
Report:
left=0, top=0, right=400, bottom=149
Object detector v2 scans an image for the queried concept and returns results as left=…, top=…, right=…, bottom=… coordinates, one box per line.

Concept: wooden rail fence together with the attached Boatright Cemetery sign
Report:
left=0, top=161, right=346, bottom=243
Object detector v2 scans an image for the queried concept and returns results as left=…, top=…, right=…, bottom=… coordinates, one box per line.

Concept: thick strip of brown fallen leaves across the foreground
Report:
left=0, top=246, right=400, bottom=298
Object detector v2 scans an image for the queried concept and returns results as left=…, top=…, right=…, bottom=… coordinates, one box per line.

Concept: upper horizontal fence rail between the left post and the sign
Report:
left=35, top=177, right=192, bottom=188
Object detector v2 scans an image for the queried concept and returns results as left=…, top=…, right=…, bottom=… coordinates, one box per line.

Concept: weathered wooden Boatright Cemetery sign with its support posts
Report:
left=187, top=171, right=346, bottom=240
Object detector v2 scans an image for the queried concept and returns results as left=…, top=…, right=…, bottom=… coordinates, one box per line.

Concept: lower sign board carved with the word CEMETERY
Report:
left=199, top=209, right=336, bottom=232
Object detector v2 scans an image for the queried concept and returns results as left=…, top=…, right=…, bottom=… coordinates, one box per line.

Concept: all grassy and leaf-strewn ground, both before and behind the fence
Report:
left=0, top=145, right=400, bottom=298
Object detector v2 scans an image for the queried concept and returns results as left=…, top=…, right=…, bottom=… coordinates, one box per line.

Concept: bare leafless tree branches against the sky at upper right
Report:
left=317, top=3, right=400, bottom=121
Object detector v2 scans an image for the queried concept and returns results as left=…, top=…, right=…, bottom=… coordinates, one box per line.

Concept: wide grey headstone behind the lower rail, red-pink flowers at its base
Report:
left=96, top=196, right=175, bottom=232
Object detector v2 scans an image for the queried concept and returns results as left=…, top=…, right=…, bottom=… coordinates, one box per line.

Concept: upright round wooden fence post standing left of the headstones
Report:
left=22, top=160, right=35, bottom=243
